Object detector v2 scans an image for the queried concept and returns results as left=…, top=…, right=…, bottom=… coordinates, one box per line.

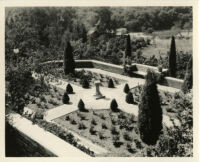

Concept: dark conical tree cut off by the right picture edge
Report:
left=182, top=56, right=193, bottom=93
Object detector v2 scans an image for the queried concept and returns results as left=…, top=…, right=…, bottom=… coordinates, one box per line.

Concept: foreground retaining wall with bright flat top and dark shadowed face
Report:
left=6, top=113, right=90, bottom=157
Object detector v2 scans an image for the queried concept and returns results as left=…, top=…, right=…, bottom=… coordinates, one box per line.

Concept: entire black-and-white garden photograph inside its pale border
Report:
left=4, top=1, right=197, bottom=158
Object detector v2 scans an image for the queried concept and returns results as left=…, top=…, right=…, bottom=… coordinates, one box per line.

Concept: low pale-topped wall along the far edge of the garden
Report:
left=41, top=60, right=183, bottom=89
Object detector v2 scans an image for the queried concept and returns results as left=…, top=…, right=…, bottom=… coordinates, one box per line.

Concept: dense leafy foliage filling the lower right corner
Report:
left=143, top=92, right=193, bottom=157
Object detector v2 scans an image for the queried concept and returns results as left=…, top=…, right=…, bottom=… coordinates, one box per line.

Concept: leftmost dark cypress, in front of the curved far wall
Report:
left=63, top=41, right=75, bottom=75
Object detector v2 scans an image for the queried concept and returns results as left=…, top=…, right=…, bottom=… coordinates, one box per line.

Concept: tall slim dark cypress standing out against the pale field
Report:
left=169, top=36, right=176, bottom=77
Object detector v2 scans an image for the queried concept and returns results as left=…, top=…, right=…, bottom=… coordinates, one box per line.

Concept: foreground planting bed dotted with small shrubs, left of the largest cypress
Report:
left=54, top=110, right=147, bottom=156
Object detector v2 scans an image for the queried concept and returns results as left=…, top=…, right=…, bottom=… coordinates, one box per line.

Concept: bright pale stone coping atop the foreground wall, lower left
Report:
left=7, top=113, right=90, bottom=157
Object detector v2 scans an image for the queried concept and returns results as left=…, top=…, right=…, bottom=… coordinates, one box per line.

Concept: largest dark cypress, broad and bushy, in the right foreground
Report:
left=138, top=70, right=162, bottom=145
